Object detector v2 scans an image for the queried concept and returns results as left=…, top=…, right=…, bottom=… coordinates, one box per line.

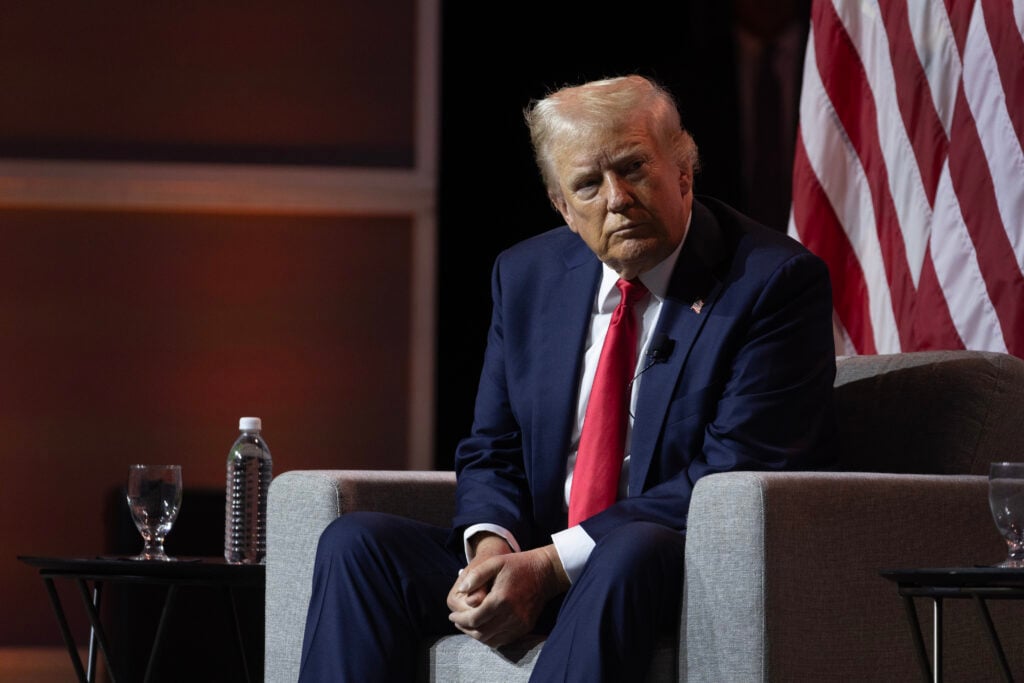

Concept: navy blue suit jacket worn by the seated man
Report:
left=452, top=198, right=836, bottom=549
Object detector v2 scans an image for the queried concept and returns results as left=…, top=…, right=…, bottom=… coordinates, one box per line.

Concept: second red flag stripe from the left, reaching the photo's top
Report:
left=812, top=2, right=914, bottom=348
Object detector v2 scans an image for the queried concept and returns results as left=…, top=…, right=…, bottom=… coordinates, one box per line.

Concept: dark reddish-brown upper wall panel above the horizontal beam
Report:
left=0, top=0, right=417, bottom=167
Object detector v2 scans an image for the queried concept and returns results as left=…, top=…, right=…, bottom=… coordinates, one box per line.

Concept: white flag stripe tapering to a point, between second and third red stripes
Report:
left=833, top=0, right=932, bottom=288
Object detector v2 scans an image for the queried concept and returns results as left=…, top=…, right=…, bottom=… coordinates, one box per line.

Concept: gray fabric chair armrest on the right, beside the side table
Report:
left=684, top=472, right=1003, bottom=681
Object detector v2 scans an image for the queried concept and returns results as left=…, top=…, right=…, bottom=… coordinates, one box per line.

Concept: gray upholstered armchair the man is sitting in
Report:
left=265, top=351, right=1024, bottom=683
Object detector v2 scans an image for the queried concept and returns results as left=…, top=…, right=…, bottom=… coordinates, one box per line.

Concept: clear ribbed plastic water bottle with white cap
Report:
left=224, top=418, right=273, bottom=564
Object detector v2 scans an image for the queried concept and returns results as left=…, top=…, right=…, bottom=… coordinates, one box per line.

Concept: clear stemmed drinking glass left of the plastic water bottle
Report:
left=128, top=465, right=181, bottom=560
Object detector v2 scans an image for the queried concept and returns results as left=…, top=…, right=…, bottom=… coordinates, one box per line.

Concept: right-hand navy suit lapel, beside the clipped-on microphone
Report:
left=630, top=202, right=726, bottom=496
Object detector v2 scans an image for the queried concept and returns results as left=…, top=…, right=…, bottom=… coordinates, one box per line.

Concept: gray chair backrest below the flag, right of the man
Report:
left=835, top=351, right=1024, bottom=475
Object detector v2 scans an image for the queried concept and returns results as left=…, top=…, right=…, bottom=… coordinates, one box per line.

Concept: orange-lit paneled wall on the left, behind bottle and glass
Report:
left=0, top=0, right=432, bottom=646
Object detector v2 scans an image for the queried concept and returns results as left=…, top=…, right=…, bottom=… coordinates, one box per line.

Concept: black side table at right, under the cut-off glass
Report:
left=880, top=567, right=1024, bottom=683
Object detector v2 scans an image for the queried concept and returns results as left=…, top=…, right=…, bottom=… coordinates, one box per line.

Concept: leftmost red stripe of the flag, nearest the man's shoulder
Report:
left=793, top=131, right=878, bottom=353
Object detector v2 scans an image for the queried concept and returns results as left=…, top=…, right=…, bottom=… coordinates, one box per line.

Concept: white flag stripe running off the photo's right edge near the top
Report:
left=964, top=2, right=1024, bottom=270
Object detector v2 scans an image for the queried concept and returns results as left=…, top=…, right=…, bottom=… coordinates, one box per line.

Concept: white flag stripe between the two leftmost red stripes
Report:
left=800, top=30, right=900, bottom=353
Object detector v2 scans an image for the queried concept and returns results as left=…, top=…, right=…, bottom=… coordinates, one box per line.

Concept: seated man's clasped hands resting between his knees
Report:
left=447, top=533, right=569, bottom=647
